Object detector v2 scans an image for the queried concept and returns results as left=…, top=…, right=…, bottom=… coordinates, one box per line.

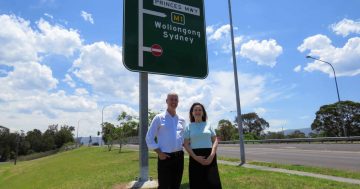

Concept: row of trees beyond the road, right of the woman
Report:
left=216, top=101, right=360, bottom=140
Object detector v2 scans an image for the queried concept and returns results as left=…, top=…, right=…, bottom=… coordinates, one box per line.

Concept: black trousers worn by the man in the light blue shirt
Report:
left=158, top=151, right=184, bottom=189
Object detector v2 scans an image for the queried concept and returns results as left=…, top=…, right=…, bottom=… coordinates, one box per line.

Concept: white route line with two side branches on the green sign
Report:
left=138, top=0, right=166, bottom=67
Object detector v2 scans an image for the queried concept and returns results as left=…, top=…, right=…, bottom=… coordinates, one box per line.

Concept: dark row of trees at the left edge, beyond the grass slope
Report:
left=0, top=124, right=75, bottom=161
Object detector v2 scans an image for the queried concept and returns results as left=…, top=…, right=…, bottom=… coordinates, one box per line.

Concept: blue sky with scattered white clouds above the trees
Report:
left=0, top=0, right=360, bottom=136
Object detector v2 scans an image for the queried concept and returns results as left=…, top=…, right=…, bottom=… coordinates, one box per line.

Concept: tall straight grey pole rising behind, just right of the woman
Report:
left=228, top=0, right=245, bottom=165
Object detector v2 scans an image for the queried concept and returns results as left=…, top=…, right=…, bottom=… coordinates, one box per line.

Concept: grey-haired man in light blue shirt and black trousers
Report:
left=146, top=93, right=185, bottom=189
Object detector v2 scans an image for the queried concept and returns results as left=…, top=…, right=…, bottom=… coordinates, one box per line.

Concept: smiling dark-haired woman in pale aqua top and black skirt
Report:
left=184, top=103, right=221, bottom=189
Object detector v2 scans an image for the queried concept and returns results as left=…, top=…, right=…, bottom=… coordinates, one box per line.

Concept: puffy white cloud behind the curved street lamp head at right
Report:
left=298, top=34, right=360, bottom=77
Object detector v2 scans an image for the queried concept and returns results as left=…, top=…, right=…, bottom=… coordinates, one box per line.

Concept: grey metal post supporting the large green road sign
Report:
left=139, top=72, right=149, bottom=182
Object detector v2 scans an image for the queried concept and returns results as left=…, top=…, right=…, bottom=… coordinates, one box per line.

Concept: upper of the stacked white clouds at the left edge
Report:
left=0, top=15, right=82, bottom=66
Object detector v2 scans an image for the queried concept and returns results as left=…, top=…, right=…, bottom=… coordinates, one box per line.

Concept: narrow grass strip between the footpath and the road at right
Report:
left=219, top=157, right=360, bottom=179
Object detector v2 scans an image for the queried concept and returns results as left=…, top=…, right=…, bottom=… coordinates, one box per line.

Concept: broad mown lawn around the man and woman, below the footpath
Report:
left=0, top=147, right=359, bottom=189
